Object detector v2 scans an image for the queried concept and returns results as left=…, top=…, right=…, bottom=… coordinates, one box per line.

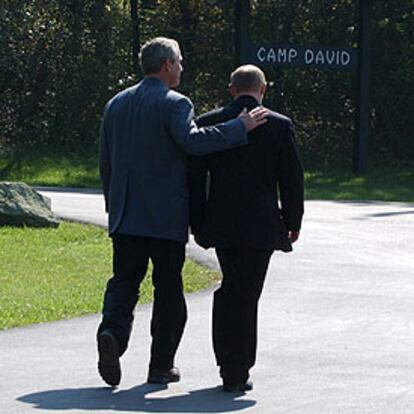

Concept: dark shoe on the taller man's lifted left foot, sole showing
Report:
left=98, top=330, right=121, bottom=387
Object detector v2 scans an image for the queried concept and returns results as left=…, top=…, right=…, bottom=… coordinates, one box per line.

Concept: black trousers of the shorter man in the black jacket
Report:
left=213, top=248, right=273, bottom=383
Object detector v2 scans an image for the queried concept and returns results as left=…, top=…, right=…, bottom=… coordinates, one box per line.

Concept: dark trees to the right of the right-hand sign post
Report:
left=371, top=0, right=414, bottom=160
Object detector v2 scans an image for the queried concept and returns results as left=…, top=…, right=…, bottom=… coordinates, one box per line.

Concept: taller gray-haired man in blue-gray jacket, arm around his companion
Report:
left=97, top=38, right=267, bottom=386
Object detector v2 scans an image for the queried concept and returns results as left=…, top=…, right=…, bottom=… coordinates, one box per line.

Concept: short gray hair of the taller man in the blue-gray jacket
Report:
left=139, top=37, right=181, bottom=75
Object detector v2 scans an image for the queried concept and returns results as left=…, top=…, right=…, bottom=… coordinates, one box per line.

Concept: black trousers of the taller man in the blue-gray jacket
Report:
left=98, top=234, right=187, bottom=370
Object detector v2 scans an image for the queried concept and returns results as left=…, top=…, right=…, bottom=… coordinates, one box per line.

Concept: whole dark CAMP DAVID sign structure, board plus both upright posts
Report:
left=235, top=0, right=372, bottom=174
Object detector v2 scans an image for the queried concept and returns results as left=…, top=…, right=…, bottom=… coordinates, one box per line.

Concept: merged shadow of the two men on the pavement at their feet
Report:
left=18, top=384, right=256, bottom=413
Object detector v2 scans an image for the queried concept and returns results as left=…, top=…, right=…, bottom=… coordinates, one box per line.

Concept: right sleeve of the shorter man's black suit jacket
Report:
left=278, top=121, right=304, bottom=231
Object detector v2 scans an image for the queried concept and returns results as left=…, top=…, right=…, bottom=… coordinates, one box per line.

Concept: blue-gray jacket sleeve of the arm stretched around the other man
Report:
left=169, top=97, right=248, bottom=155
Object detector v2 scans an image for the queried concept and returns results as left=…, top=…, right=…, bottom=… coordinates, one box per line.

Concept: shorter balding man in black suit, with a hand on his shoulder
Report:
left=190, top=65, right=303, bottom=391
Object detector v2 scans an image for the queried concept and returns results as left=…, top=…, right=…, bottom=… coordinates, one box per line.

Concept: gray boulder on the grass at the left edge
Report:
left=0, top=181, right=59, bottom=227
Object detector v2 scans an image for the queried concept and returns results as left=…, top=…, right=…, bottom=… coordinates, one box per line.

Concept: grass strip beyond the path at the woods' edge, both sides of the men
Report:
left=0, top=154, right=414, bottom=202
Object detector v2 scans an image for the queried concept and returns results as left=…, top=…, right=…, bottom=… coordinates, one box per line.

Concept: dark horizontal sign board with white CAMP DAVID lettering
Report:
left=250, top=45, right=358, bottom=69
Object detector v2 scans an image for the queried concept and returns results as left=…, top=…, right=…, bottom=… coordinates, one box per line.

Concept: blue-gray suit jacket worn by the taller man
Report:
left=99, top=77, right=247, bottom=242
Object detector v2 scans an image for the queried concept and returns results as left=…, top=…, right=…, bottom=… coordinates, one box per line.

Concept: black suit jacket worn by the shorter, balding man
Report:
left=190, top=96, right=303, bottom=251
